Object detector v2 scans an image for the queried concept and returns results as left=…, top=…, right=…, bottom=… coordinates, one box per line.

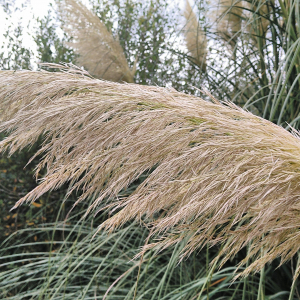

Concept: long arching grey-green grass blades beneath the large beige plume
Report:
left=0, top=206, right=292, bottom=300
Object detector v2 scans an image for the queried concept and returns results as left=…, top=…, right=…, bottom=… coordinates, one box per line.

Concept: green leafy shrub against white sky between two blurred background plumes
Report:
left=90, top=0, right=201, bottom=89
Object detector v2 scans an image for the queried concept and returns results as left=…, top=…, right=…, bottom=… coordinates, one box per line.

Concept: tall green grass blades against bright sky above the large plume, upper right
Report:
left=197, top=0, right=300, bottom=128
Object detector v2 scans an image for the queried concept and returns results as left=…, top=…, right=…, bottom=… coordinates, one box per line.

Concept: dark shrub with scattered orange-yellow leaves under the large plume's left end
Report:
left=0, top=134, right=75, bottom=250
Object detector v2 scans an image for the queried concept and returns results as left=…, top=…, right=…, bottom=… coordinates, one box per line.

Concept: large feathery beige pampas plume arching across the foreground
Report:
left=0, top=70, right=300, bottom=274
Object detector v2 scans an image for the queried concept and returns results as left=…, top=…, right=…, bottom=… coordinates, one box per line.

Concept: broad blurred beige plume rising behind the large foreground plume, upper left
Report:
left=59, top=0, right=135, bottom=82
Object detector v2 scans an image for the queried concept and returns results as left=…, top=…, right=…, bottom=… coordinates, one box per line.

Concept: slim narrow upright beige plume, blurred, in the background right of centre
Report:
left=184, top=0, right=207, bottom=71
